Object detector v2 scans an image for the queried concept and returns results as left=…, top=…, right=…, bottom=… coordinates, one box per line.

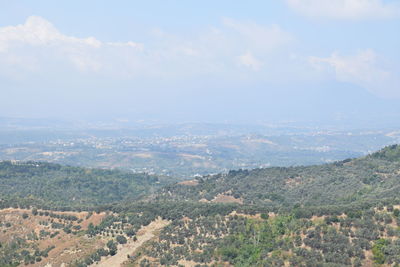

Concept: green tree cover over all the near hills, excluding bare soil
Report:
left=0, top=145, right=400, bottom=267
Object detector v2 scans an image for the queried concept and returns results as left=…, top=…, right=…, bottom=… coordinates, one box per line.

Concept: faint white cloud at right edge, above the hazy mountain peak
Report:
left=309, top=49, right=400, bottom=97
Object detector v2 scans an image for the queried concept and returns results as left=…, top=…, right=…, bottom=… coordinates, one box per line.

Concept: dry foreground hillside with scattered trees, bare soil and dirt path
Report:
left=0, top=202, right=400, bottom=267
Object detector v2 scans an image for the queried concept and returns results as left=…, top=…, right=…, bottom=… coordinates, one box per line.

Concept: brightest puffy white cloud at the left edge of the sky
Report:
left=0, top=16, right=143, bottom=72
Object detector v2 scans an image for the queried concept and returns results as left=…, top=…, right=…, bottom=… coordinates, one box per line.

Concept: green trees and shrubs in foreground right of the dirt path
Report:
left=127, top=206, right=400, bottom=266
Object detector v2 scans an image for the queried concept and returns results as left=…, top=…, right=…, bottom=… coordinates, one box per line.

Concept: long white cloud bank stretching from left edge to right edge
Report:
left=0, top=16, right=400, bottom=98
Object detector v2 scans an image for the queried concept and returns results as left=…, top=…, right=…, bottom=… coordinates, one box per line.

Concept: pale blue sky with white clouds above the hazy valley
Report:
left=0, top=0, right=400, bottom=123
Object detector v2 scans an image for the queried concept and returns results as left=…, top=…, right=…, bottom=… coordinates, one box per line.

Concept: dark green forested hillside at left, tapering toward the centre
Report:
left=0, top=161, right=170, bottom=208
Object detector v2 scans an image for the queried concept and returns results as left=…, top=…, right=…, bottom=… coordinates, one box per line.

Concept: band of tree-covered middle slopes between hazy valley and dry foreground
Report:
left=0, top=145, right=400, bottom=211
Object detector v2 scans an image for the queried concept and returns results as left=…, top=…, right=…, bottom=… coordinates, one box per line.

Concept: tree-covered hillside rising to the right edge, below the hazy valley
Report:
left=158, top=145, right=400, bottom=207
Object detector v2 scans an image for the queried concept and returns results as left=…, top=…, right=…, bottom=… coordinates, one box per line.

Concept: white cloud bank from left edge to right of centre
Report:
left=0, top=16, right=293, bottom=79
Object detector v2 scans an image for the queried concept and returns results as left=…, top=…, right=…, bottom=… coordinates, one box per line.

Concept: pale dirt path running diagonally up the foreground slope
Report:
left=92, top=219, right=169, bottom=267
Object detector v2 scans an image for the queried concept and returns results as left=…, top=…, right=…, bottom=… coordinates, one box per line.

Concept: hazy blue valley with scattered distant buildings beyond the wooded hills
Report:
left=0, top=123, right=400, bottom=180
